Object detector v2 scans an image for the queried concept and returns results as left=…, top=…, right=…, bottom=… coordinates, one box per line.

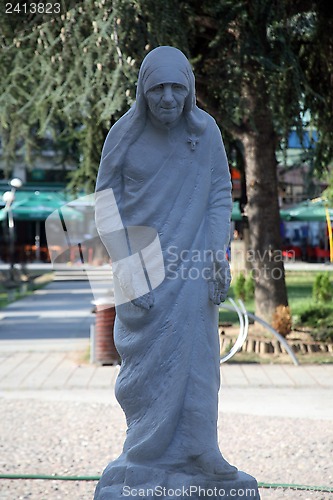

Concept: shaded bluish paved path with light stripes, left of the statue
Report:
left=0, top=269, right=110, bottom=350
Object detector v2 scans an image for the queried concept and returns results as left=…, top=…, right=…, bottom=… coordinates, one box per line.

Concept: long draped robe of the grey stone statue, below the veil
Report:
left=97, top=108, right=232, bottom=468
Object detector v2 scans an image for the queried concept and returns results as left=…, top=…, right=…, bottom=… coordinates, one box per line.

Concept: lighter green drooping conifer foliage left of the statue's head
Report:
left=0, top=0, right=186, bottom=191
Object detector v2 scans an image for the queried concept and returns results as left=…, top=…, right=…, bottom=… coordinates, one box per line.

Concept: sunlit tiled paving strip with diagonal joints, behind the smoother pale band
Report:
left=0, top=341, right=333, bottom=390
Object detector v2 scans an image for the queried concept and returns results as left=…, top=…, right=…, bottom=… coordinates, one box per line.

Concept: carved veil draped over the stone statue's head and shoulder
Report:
left=96, top=46, right=207, bottom=191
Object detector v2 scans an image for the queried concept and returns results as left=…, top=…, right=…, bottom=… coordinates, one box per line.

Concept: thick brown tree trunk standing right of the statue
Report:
left=242, top=81, right=288, bottom=322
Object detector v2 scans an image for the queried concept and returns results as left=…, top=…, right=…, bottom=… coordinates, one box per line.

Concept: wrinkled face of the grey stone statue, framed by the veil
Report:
left=146, top=83, right=188, bottom=125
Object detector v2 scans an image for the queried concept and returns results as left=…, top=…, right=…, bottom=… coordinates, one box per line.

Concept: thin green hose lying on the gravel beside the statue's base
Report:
left=0, top=474, right=333, bottom=493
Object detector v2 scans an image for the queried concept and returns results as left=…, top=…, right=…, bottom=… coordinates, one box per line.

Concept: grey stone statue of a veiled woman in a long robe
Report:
left=95, top=47, right=257, bottom=500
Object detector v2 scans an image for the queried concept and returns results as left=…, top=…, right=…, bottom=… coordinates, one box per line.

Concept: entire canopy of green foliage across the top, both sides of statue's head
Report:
left=0, top=0, right=333, bottom=187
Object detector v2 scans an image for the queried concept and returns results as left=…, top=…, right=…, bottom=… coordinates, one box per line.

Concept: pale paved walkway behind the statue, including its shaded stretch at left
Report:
left=0, top=280, right=333, bottom=420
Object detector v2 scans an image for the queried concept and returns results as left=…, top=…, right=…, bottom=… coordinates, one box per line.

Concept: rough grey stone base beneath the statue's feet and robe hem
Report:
left=94, top=462, right=260, bottom=500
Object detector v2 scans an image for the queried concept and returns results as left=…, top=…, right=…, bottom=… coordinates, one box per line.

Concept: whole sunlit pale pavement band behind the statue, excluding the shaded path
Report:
left=0, top=348, right=333, bottom=421
